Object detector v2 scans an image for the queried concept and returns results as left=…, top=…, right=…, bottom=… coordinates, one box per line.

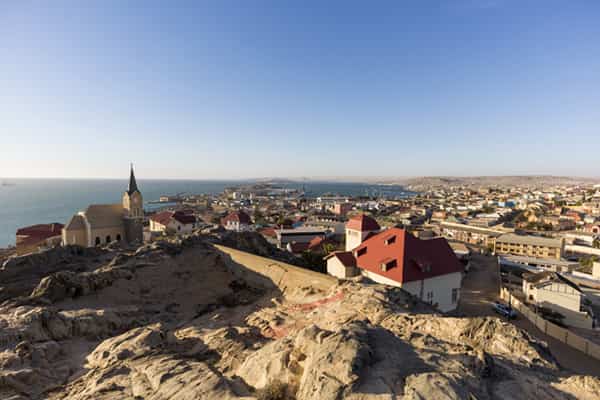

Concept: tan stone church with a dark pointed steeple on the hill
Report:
left=62, top=166, right=144, bottom=247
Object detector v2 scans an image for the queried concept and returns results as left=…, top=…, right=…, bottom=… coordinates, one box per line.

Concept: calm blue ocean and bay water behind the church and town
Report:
left=0, top=179, right=412, bottom=247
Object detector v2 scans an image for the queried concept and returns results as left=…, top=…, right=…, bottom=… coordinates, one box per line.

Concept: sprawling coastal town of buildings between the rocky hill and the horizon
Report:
left=0, top=168, right=600, bottom=360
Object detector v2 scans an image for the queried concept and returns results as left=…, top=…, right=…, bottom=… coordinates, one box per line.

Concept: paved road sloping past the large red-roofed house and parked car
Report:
left=457, top=254, right=600, bottom=376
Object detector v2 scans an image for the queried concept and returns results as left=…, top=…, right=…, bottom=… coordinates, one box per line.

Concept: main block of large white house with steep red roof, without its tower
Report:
left=353, top=228, right=464, bottom=312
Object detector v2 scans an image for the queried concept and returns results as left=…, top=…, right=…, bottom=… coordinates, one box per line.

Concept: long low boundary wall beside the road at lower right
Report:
left=500, top=287, right=600, bottom=360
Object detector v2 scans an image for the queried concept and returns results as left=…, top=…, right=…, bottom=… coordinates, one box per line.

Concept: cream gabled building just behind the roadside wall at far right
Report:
left=523, top=271, right=593, bottom=329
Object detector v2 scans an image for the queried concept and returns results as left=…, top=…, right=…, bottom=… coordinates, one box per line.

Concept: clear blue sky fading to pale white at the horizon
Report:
left=0, top=0, right=600, bottom=179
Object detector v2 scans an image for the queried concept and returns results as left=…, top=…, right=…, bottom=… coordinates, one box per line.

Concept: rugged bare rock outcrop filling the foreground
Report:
left=0, top=233, right=600, bottom=400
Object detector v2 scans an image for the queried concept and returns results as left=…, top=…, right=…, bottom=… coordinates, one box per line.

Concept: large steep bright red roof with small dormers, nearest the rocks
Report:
left=354, top=228, right=464, bottom=283
